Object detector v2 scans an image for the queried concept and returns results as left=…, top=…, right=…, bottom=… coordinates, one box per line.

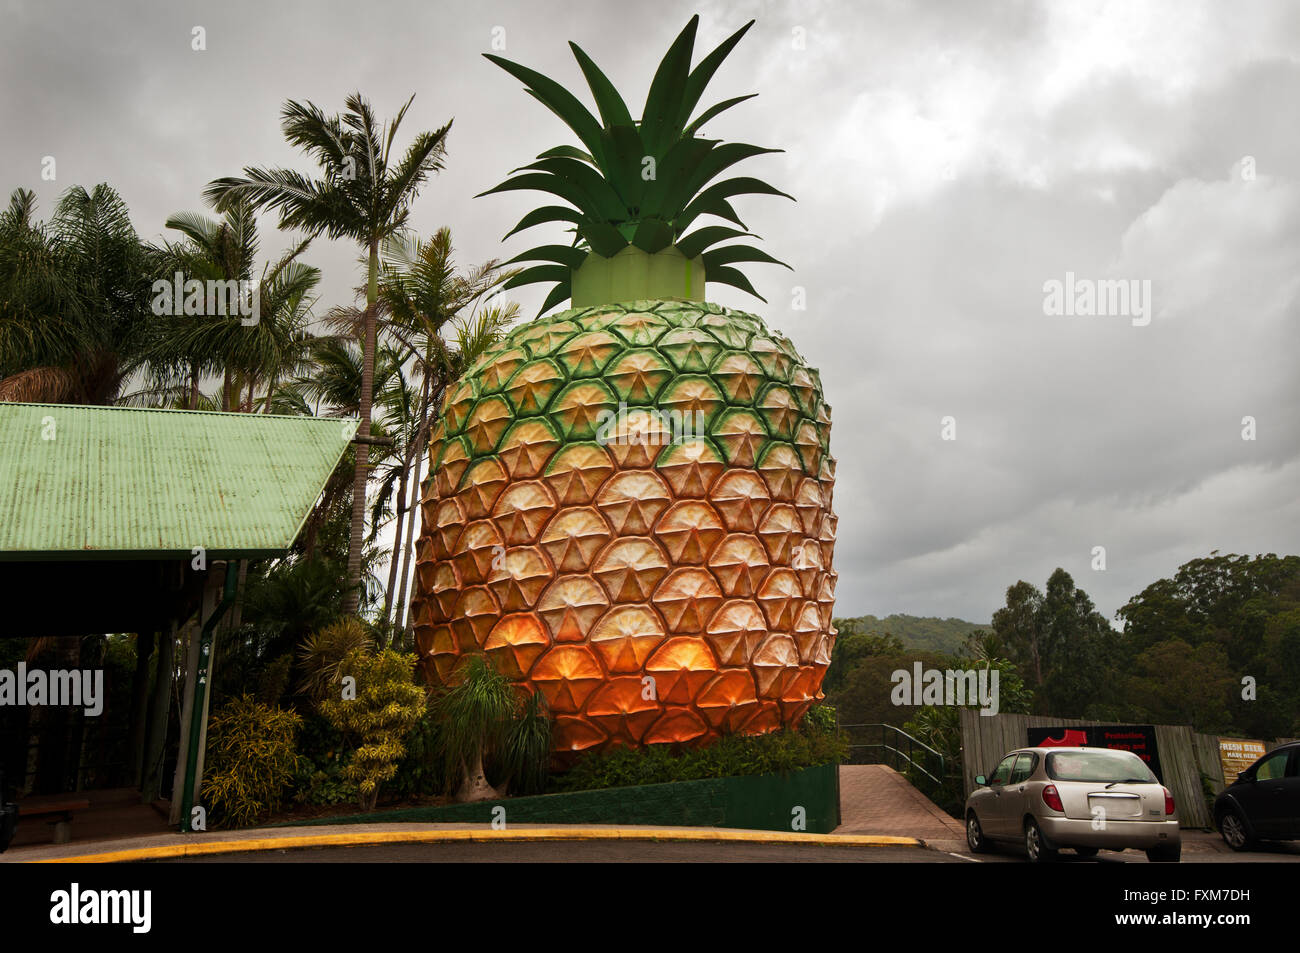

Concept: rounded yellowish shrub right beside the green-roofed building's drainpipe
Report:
left=203, top=696, right=302, bottom=827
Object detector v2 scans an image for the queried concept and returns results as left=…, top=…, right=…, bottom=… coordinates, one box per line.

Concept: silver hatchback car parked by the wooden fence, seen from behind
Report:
left=966, top=748, right=1183, bottom=863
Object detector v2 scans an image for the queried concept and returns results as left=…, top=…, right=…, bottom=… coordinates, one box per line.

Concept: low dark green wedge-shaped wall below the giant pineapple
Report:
left=282, top=764, right=840, bottom=833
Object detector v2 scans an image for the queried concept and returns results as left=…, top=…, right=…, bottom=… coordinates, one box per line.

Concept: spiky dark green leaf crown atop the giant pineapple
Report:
left=476, top=16, right=793, bottom=313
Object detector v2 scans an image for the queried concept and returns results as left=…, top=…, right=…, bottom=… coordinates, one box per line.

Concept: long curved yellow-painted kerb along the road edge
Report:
left=31, top=827, right=926, bottom=863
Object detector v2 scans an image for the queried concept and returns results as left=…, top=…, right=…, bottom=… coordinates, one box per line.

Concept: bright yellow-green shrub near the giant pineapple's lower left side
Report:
left=320, top=649, right=425, bottom=811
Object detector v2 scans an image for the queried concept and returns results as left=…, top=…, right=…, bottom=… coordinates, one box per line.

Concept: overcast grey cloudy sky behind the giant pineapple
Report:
left=0, top=0, right=1300, bottom=621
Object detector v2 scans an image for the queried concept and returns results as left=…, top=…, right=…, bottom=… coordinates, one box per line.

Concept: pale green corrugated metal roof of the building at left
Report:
left=0, top=402, right=356, bottom=559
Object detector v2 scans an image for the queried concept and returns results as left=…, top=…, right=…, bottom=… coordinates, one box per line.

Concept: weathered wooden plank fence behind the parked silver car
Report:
left=961, top=709, right=1274, bottom=827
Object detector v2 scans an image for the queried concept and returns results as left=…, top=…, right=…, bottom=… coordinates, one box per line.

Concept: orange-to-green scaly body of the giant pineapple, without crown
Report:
left=411, top=300, right=836, bottom=751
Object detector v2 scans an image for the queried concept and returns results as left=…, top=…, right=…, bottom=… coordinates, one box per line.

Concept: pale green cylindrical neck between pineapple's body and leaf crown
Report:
left=572, top=244, right=705, bottom=308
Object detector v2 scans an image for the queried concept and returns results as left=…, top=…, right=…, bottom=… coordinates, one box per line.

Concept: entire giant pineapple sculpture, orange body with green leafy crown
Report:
left=412, top=18, right=836, bottom=751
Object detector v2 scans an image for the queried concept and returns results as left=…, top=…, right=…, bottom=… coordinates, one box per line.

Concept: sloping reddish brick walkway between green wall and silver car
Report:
left=835, top=764, right=966, bottom=848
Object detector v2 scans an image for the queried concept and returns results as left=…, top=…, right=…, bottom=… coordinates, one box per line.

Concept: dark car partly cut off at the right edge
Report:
left=1214, top=741, right=1300, bottom=850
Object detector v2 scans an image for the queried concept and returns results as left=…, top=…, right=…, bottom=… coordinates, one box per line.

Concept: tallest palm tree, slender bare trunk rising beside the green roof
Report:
left=205, top=92, right=451, bottom=612
